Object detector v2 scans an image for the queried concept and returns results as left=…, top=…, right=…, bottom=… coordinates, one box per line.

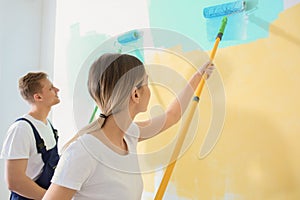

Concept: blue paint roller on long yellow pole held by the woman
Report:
left=154, top=1, right=245, bottom=200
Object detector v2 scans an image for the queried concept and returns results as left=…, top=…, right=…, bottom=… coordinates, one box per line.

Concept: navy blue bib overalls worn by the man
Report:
left=10, top=118, right=59, bottom=200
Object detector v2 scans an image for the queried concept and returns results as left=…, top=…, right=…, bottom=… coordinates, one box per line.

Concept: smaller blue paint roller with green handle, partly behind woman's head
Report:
left=89, top=30, right=143, bottom=123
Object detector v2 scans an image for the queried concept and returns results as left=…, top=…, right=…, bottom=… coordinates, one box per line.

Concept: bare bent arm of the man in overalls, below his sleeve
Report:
left=6, top=159, right=46, bottom=199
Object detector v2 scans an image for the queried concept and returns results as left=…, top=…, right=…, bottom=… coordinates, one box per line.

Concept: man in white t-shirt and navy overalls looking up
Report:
left=1, top=72, right=60, bottom=200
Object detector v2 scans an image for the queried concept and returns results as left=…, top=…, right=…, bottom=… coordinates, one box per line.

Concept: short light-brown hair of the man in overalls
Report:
left=19, top=72, right=48, bottom=103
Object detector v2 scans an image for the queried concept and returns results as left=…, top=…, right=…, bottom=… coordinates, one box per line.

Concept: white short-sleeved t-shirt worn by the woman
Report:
left=52, top=124, right=143, bottom=200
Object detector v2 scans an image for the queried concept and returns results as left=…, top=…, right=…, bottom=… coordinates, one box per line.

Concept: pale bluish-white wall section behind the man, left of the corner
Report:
left=0, top=0, right=56, bottom=199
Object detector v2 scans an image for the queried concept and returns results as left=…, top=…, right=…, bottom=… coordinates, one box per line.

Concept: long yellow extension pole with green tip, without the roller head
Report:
left=154, top=17, right=227, bottom=200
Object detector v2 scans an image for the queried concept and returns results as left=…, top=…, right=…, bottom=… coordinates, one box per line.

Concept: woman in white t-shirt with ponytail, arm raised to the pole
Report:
left=43, top=54, right=214, bottom=200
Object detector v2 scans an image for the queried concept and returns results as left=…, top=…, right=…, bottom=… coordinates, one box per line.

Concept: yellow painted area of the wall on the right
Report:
left=139, top=4, right=300, bottom=200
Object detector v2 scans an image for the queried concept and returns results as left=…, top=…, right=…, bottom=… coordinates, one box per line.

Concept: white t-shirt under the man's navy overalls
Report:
left=1, top=114, right=56, bottom=181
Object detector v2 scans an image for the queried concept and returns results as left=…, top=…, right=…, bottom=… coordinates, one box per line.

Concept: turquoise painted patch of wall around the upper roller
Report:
left=149, top=0, right=284, bottom=50
